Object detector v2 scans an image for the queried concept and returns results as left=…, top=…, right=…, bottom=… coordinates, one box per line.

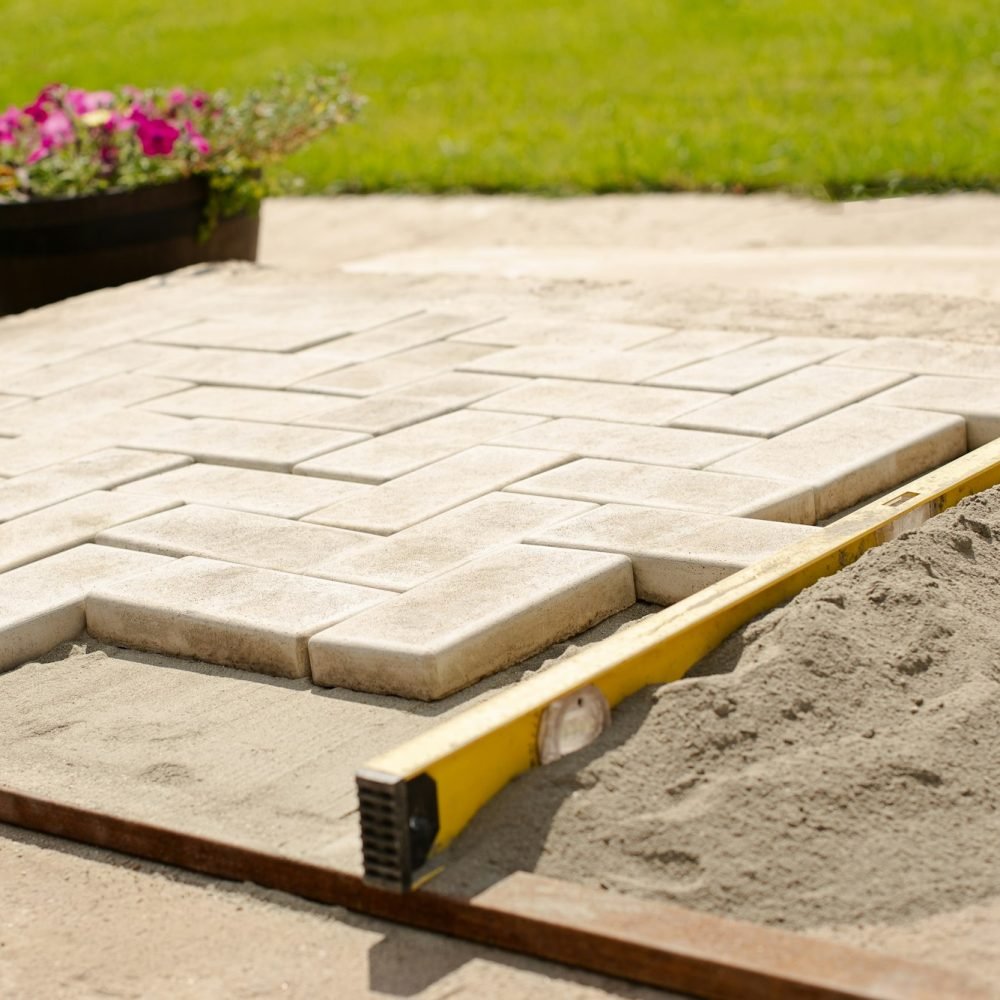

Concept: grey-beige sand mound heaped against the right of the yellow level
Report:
left=441, top=489, right=1000, bottom=928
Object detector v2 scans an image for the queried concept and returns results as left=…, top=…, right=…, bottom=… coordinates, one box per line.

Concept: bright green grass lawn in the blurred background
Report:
left=0, top=0, right=1000, bottom=197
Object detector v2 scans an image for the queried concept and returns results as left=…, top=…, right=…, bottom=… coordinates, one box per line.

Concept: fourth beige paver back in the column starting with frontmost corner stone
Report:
left=294, top=410, right=543, bottom=483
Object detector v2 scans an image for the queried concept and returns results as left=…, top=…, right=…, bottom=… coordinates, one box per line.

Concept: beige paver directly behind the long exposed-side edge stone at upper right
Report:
left=672, top=365, right=908, bottom=437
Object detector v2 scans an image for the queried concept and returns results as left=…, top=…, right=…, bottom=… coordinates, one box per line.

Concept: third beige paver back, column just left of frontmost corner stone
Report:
left=119, top=462, right=373, bottom=518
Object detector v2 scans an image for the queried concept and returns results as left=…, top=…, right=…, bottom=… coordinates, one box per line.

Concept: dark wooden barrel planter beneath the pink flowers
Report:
left=0, top=177, right=260, bottom=315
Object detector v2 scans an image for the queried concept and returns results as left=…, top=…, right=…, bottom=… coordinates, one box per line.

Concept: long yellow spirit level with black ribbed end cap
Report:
left=357, top=439, right=1000, bottom=892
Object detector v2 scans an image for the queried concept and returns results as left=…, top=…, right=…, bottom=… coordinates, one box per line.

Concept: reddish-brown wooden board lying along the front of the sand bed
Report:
left=0, top=788, right=990, bottom=1000
